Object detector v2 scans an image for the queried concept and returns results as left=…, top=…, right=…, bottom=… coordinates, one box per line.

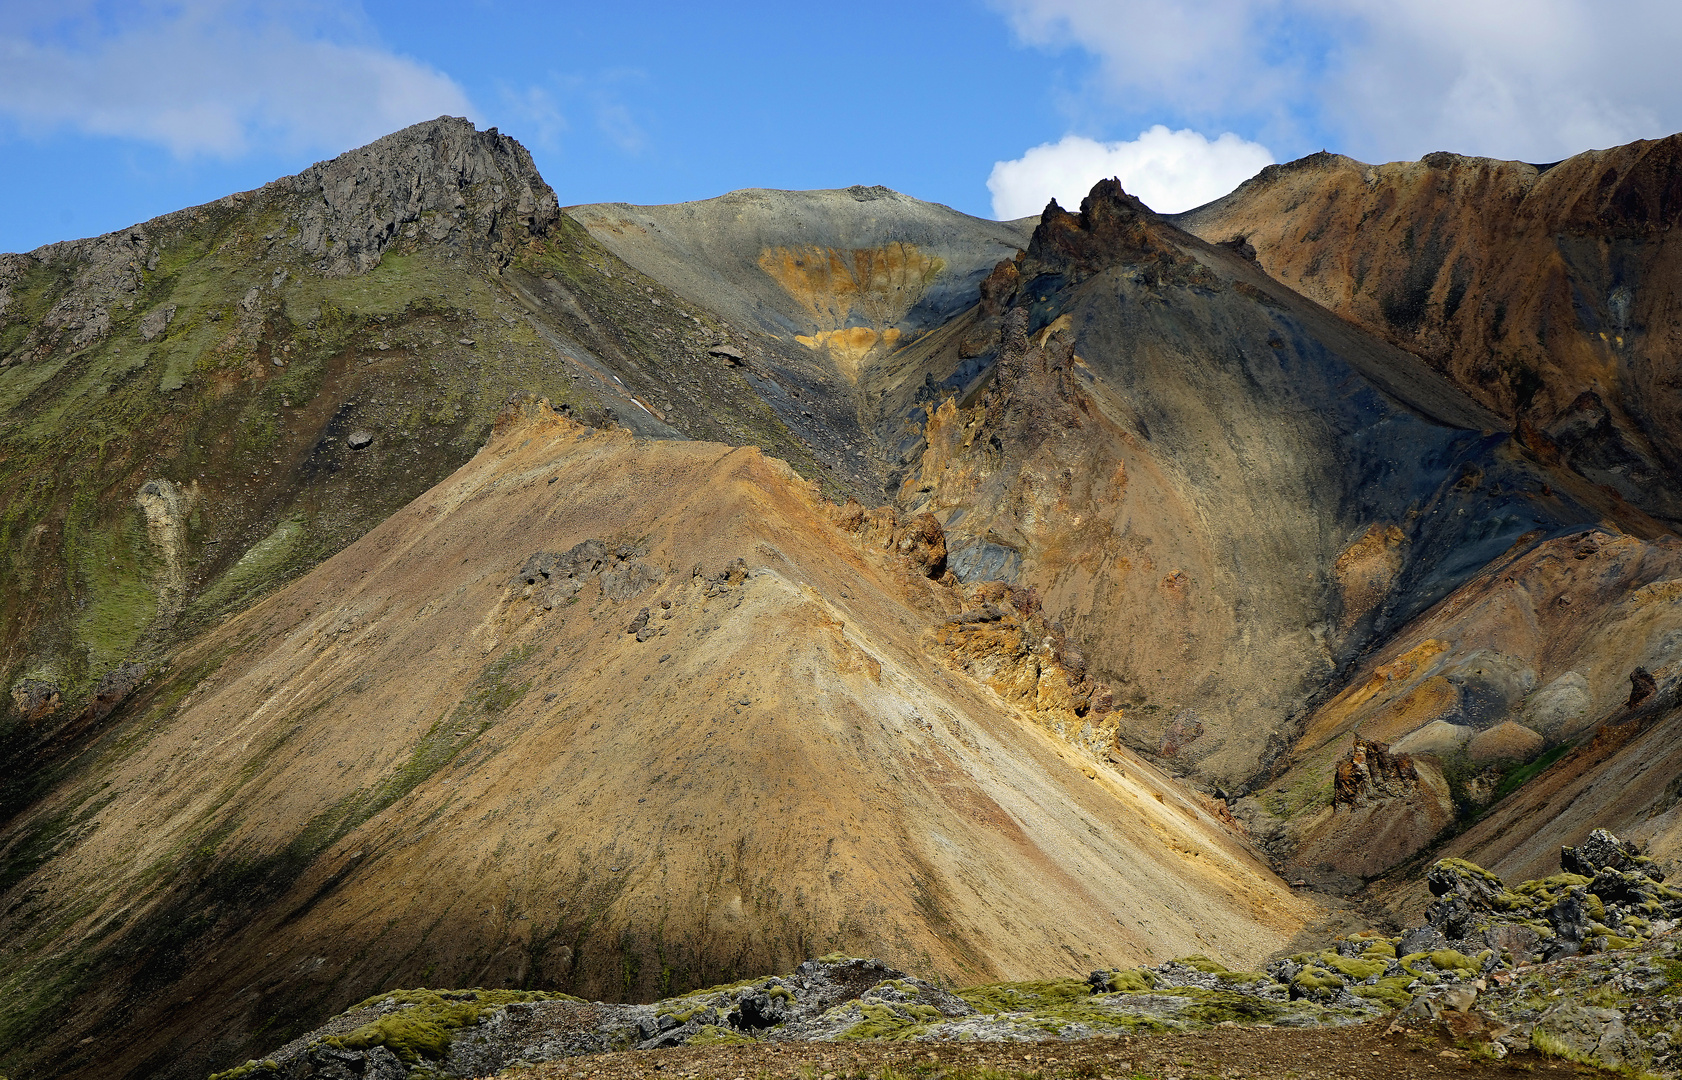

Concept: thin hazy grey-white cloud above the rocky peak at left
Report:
left=0, top=0, right=471, bottom=158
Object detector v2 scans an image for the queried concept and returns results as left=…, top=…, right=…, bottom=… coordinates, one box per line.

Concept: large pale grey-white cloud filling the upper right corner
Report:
left=994, top=0, right=1682, bottom=161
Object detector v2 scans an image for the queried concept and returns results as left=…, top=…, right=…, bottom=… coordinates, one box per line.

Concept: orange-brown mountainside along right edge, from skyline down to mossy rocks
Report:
left=1176, top=136, right=1682, bottom=876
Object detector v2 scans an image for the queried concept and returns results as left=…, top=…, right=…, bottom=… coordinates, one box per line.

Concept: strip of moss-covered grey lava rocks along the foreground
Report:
left=212, top=829, right=1682, bottom=1080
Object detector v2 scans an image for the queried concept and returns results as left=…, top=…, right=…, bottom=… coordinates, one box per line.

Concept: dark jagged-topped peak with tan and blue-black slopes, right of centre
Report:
left=902, top=182, right=1598, bottom=791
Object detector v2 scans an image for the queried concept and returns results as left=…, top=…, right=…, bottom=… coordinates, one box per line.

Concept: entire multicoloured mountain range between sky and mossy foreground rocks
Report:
left=0, top=118, right=1682, bottom=1080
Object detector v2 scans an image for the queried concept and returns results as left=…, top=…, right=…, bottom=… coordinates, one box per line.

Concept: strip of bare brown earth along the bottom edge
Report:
left=501, top=1019, right=1611, bottom=1080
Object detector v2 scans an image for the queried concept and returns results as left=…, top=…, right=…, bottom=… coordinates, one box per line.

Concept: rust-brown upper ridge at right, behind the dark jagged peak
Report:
left=1176, top=136, right=1682, bottom=523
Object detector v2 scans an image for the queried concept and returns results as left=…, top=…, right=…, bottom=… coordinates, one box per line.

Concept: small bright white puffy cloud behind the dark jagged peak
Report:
left=987, top=124, right=1273, bottom=220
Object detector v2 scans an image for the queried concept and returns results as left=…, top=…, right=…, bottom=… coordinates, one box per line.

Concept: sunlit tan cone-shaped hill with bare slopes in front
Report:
left=0, top=409, right=1314, bottom=1075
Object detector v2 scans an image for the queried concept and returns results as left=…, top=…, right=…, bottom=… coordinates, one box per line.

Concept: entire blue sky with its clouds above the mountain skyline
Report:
left=0, top=0, right=1682, bottom=251
